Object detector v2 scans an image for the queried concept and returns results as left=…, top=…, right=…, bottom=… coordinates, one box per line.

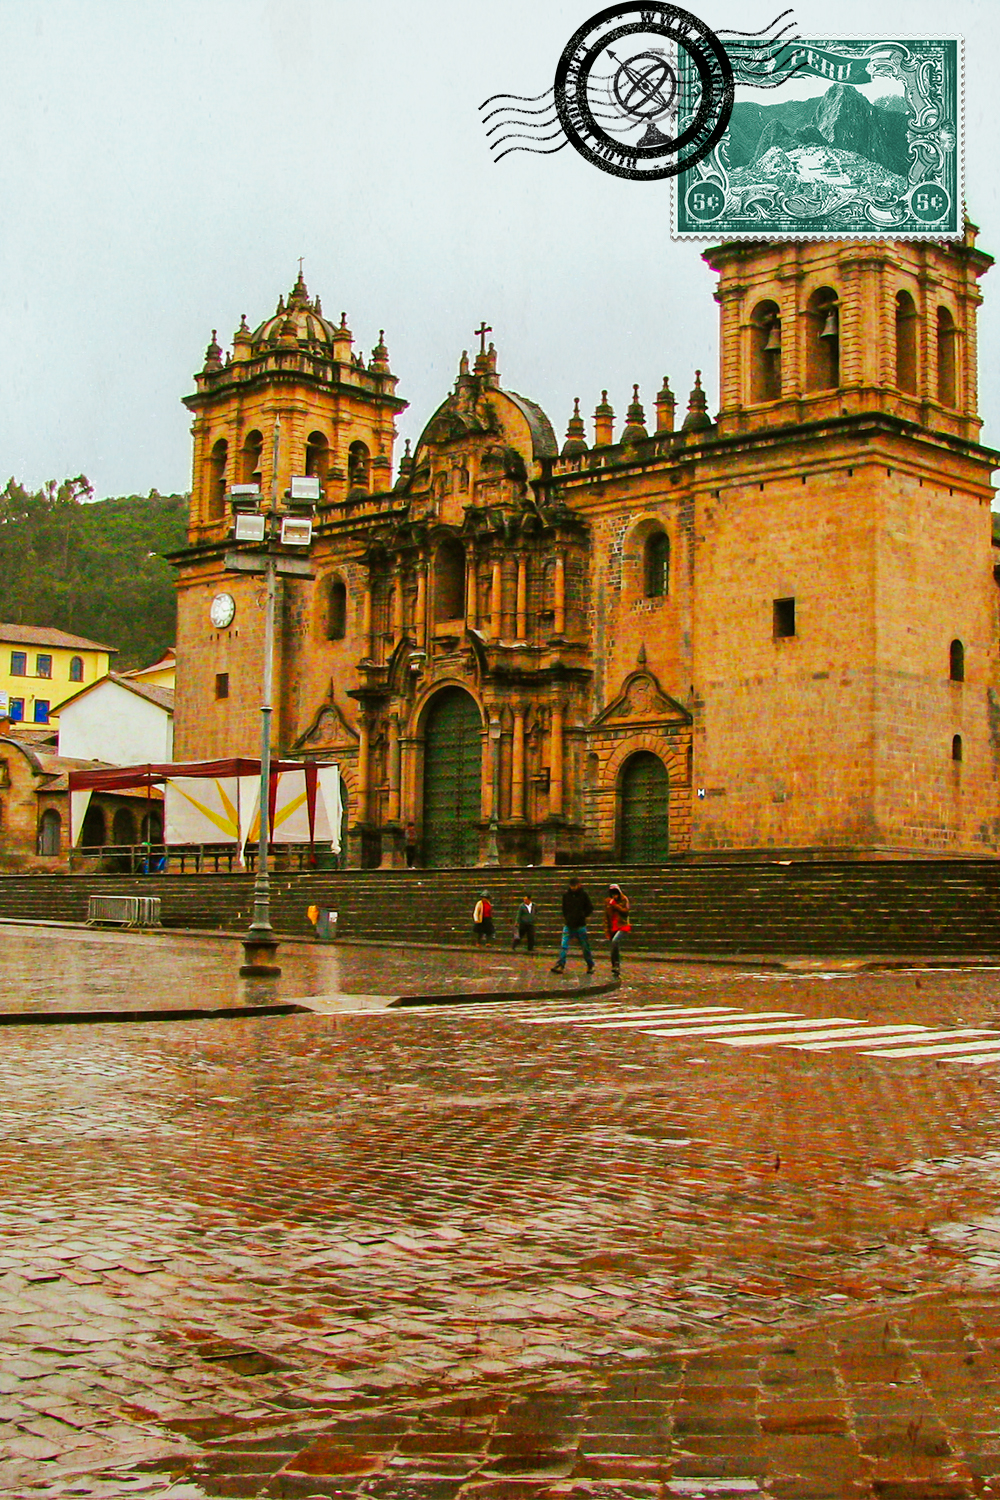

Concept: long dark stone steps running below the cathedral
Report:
left=0, top=860, right=1000, bottom=956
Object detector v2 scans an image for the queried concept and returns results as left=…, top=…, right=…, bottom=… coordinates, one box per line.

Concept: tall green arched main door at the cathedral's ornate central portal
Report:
left=423, top=687, right=483, bottom=869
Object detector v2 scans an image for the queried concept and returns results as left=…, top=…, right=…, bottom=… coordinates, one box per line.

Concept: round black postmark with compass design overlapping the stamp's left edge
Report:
left=555, top=0, right=735, bottom=182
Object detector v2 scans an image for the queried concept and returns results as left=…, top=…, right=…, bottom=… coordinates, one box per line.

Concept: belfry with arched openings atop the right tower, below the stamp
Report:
left=705, top=224, right=993, bottom=443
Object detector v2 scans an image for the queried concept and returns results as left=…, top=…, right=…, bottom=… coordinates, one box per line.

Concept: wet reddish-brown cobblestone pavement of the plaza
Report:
left=0, top=929, right=1000, bottom=1500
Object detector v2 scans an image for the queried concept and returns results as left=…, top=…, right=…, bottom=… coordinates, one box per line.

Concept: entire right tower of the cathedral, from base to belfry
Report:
left=693, top=225, right=1000, bottom=857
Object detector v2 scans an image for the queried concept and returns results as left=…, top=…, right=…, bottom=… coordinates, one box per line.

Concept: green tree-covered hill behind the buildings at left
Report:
left=0, top=474, right=187, bottom=671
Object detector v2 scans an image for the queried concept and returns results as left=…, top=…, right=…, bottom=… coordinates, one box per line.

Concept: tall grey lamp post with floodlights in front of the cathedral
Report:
left=225, top=420, right=319, bottom=977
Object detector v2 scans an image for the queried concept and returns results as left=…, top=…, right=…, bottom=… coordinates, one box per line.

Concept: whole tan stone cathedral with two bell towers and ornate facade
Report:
left=174, top=225, right=1000, bottom=867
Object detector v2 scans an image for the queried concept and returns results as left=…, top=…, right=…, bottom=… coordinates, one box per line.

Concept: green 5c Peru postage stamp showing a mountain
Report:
left=673, top=38, right=964, bottom=240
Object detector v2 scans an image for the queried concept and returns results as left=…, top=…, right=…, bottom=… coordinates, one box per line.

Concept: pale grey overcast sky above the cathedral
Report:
left=0, top=0, right=1000, bottom=497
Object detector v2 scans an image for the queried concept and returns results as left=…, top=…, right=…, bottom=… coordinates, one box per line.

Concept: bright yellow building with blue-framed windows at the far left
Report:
left=0, top=624, right=117, bottom=725
